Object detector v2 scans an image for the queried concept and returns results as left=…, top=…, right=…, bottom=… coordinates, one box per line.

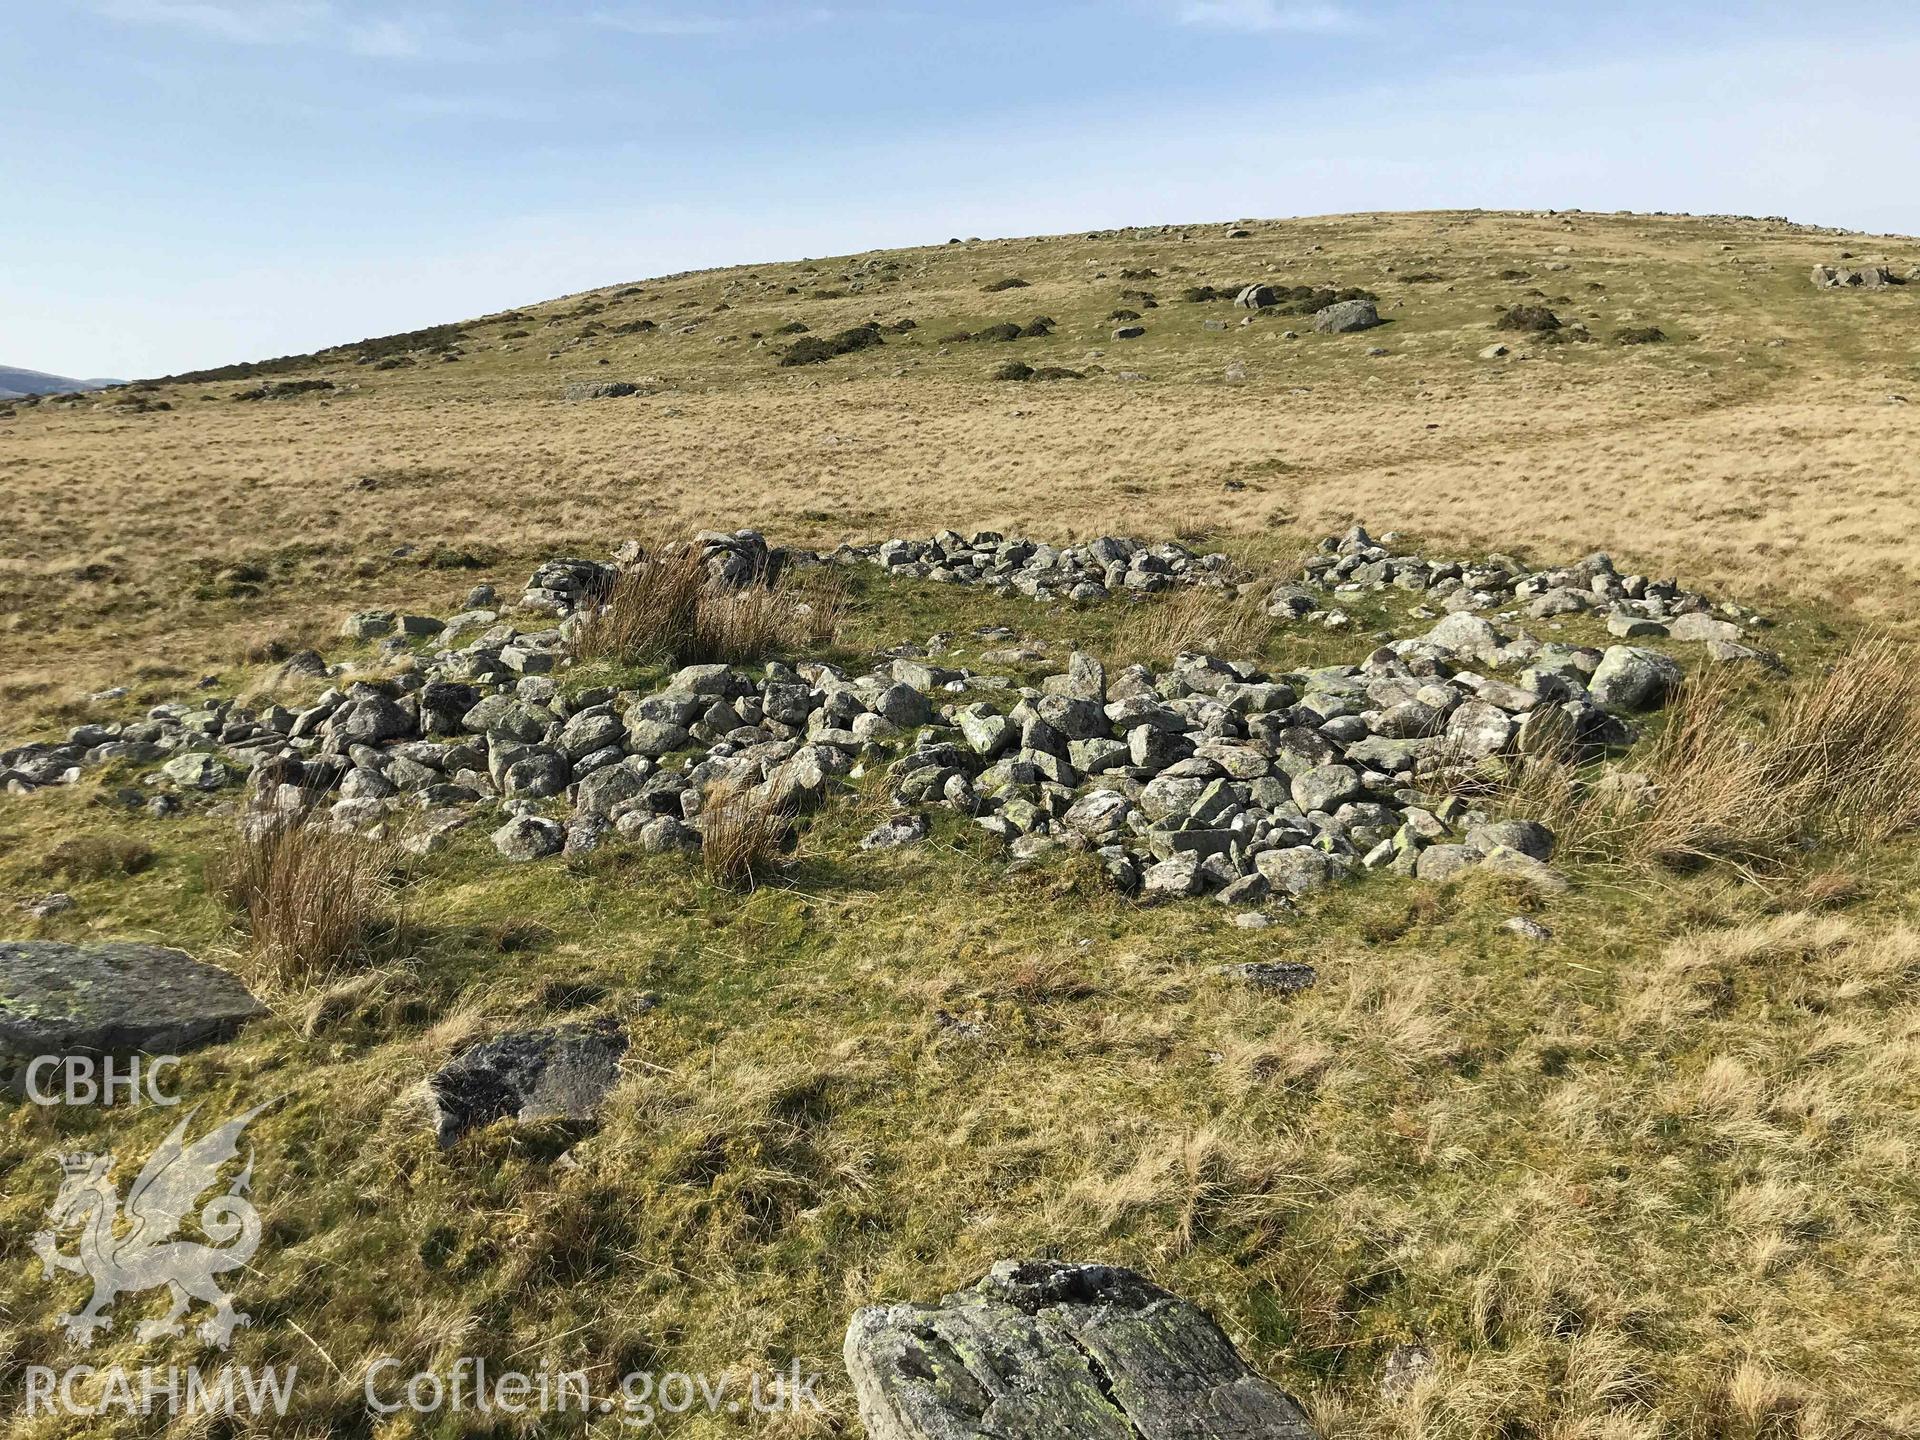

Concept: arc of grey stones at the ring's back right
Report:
left=1267, top=526, right=1772, bottom=662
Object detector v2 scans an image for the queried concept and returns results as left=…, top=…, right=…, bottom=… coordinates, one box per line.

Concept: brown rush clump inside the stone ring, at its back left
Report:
left=572, top=543, right=845, bottom=666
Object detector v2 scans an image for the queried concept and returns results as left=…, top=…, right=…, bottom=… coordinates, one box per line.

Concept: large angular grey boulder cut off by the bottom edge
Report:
left=843, top=1260, right=1313, bottom=1440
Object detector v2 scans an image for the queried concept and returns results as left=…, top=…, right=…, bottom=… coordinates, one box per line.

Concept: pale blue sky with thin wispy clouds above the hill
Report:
left=0, top=0, right=1920, bottom=376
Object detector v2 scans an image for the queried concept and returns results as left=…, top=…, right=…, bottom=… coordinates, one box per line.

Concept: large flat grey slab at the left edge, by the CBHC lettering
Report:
left=0, top=941, right=267, bottom=1056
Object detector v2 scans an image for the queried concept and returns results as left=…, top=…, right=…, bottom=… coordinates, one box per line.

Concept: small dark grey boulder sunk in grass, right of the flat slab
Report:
left=426, top=1016, right=628, bottom=1146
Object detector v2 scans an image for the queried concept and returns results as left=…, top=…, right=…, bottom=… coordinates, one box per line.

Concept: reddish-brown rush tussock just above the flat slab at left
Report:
left=207, top=818, right=399, bottom=987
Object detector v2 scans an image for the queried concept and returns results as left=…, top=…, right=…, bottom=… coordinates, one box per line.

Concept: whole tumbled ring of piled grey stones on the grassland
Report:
left=0, top=530, right=1730, bottom=904
